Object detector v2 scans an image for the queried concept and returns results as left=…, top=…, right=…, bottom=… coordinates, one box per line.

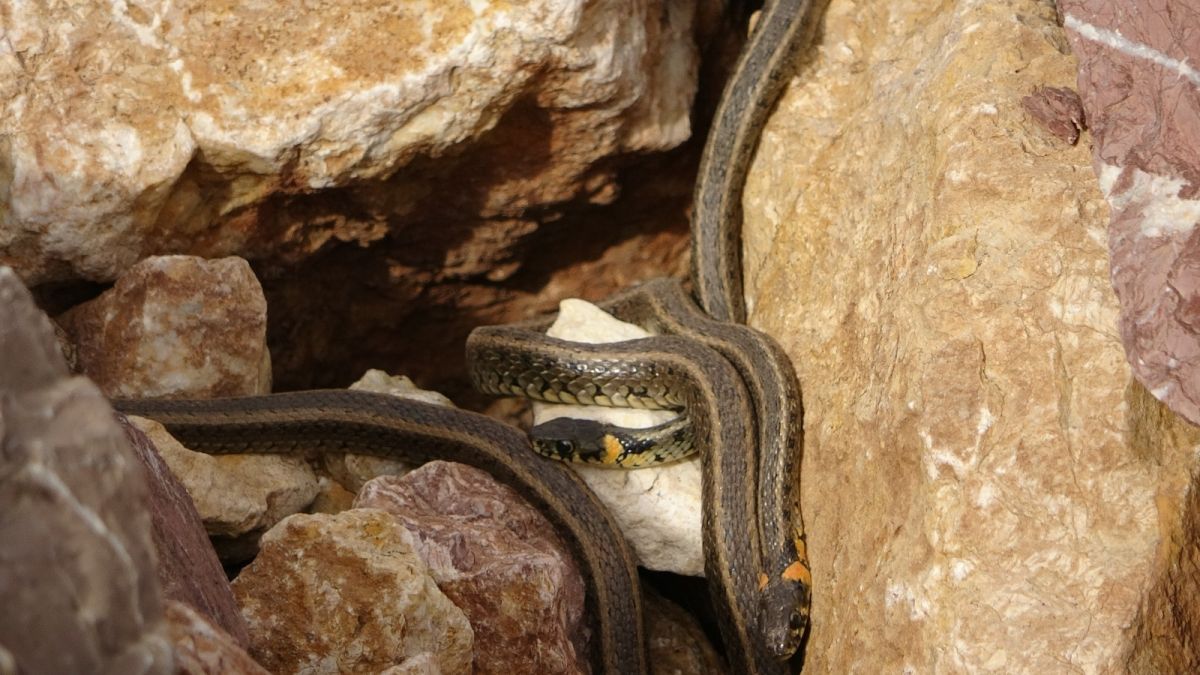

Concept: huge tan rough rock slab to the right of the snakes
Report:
left=744, top=0, right=1200, bottom=673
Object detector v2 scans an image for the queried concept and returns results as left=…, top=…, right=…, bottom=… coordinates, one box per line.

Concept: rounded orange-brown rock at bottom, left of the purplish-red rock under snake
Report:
left=233, top=509, right=472, bottom=675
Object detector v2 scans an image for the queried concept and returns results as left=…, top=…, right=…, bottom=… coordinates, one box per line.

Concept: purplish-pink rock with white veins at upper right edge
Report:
left=1061, top=0, right=1200, bottom=424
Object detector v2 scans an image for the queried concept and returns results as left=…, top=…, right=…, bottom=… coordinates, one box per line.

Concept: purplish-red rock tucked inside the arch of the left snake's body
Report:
left=354, top=461, right=587, bottom=673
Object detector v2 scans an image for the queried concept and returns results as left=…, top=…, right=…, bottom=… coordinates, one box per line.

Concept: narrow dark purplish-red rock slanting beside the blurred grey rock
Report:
left=118, top=416, right=250, bottom=646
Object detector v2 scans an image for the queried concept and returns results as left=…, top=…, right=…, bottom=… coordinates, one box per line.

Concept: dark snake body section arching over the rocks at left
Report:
left=114, top=389, right=647, bottom=674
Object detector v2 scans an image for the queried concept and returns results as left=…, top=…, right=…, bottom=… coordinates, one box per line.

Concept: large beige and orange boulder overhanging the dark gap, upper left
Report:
left=0, top=0, right=696, bottom=282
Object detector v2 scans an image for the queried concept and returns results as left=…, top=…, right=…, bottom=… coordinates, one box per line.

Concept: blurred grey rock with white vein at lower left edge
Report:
left=0, top=268, right=173, bottom=674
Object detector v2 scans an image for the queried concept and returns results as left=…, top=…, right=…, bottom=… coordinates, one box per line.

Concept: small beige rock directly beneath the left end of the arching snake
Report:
left=130, top=417, right=317, bottom=538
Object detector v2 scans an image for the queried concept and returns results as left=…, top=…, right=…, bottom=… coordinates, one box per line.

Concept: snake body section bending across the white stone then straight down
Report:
left=467, top=327, right=787, bottom=675
